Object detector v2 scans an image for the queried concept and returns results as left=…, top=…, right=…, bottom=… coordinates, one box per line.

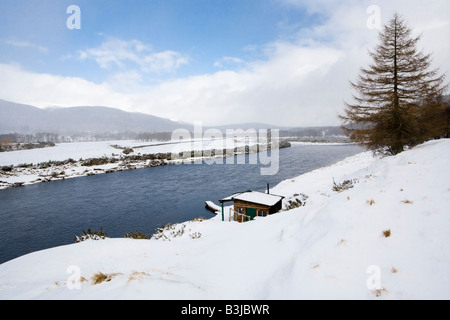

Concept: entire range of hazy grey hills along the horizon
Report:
left=0, top=99, right=342, bottom=138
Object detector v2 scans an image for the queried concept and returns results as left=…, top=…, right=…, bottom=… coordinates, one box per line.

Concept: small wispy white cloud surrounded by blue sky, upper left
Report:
left=78, top=37, right=189, bottom=73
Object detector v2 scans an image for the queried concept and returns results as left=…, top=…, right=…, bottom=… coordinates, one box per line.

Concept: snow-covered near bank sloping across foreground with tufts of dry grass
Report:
left=0, top=140, right=450, bottom=300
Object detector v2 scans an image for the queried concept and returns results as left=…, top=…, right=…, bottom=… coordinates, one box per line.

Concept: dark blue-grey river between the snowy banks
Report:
left=0, top=145, right=362, bottom=263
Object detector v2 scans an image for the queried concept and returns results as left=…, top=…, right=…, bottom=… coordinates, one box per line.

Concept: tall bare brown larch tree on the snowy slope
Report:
left=339, top=13, right=447, bottom=155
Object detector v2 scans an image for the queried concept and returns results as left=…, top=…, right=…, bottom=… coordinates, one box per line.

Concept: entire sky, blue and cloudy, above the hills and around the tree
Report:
left=0, top=0, right=450, bottom=127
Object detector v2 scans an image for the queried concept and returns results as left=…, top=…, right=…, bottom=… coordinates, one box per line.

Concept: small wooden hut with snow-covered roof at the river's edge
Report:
left=219, top=190, right=284, bottom=222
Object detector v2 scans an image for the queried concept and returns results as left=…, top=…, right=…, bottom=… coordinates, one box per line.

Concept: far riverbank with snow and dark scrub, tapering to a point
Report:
left=0, top=140, right=290, bottom=189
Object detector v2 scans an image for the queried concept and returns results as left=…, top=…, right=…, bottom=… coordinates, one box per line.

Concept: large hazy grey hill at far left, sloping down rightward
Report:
left=0, top=100, right=191, bottom=135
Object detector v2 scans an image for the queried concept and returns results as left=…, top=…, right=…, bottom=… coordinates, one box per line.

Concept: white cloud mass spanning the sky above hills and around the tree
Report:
left=0, top=0, right=450, bottom=126
